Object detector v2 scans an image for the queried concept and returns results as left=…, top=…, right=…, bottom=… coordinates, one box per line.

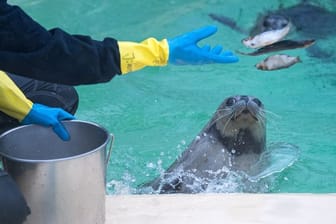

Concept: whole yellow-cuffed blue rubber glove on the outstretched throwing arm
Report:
left=118, top=26, right=239, bottom=74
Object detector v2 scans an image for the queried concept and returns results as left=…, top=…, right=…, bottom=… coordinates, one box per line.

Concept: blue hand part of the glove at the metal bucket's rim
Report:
left=21, top=103, right=75, bottom=141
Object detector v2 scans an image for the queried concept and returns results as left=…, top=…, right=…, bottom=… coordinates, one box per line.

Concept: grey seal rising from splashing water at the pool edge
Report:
left=144, top=95, right=266, bottom=193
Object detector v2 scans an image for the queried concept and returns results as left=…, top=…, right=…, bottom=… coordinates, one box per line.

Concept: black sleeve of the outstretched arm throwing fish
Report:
left=0, top=0, right=121, bottom=85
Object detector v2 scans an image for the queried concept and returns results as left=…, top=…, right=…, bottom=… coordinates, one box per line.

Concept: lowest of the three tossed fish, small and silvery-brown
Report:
left=255, top=54, right=301, bottom=71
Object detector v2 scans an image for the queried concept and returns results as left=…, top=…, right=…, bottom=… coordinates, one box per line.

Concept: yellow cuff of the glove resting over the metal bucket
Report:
left=0, top=71, right=33, bottom=122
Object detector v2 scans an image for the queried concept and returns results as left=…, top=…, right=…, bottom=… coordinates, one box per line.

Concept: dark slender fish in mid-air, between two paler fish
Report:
left=237, top=40, right=315, bottom=56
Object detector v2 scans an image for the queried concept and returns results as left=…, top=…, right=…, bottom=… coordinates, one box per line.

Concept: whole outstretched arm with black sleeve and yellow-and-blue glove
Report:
left=0, top=0, right=238, bottom=85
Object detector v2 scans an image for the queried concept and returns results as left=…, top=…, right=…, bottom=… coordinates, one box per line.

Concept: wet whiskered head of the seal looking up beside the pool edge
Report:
left=213, top=95, right=266, bottom=155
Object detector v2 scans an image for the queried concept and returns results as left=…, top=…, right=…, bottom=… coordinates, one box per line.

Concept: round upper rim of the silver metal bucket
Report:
left=0, top=120, right=111, bottom=163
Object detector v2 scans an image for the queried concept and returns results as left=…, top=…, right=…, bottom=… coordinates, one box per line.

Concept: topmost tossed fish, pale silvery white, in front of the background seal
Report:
left=242, top=23, right=291, bottom=48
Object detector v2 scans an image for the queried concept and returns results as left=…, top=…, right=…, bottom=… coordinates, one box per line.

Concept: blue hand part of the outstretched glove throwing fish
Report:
left=168, top=26, right=238, bottom=65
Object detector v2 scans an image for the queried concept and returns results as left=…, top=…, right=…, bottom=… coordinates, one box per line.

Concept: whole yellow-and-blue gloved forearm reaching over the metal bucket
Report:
left=0, top=71, right=74, bottom=140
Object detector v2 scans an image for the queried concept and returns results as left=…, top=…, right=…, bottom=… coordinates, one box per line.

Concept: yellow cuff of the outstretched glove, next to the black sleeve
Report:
left=118, top=38, right=169, bottom=74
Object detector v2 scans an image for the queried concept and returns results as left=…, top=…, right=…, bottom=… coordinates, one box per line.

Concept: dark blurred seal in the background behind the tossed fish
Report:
left=209, top=0, right=336, bottom=59
